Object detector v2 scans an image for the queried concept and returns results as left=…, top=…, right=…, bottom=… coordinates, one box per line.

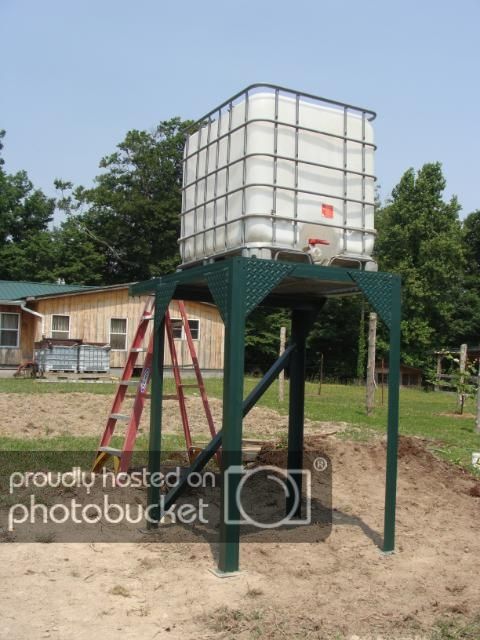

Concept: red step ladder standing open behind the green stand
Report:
left=93, top=297, right=220, bottom=473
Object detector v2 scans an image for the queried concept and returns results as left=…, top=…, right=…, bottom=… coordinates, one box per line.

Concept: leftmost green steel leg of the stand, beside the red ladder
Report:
left=147, top=303, right=165, bottom=529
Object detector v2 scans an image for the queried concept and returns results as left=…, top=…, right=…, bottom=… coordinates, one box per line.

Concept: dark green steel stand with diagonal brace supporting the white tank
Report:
left=130, top=257, right=401, bottom=573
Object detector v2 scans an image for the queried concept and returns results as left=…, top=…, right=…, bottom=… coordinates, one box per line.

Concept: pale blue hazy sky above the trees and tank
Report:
left=0, top=0, right=480, bottom=216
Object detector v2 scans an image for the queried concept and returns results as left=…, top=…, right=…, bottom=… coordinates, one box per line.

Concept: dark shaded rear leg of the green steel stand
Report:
left=286, top=310, right=311, bottom=518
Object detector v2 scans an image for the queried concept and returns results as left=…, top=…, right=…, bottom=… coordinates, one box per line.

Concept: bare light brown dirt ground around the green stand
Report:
left=0, top=394, right=480, bottom=640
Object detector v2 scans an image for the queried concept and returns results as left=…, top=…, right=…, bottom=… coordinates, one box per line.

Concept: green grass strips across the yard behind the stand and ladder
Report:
left=0, top=377, right=480, bottom=470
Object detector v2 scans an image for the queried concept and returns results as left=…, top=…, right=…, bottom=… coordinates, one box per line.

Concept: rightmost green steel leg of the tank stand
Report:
left=383, top=278, right=401, bottom=552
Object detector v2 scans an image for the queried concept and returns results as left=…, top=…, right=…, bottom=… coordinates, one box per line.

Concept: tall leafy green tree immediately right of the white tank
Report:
left=375, top=162, right=465, bottom=366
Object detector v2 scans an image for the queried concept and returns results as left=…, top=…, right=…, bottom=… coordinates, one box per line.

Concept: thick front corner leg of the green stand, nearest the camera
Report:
left=218, top=260, right=246, bottom=573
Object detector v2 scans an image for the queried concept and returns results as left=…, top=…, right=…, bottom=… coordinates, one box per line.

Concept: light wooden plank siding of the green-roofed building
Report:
left=31, top=288, right=224, bottom=370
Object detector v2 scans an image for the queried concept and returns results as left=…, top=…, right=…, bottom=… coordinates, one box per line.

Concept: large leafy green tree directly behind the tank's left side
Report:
left=58, top=118, right=193, bottom=284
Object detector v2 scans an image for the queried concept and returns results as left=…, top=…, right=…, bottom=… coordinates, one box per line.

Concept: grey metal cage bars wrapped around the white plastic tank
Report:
left=179, top=84, right=376, bottom=264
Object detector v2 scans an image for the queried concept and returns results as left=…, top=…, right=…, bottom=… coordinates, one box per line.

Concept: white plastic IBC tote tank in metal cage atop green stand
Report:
left=179, top=85, right=376, bottom=270
